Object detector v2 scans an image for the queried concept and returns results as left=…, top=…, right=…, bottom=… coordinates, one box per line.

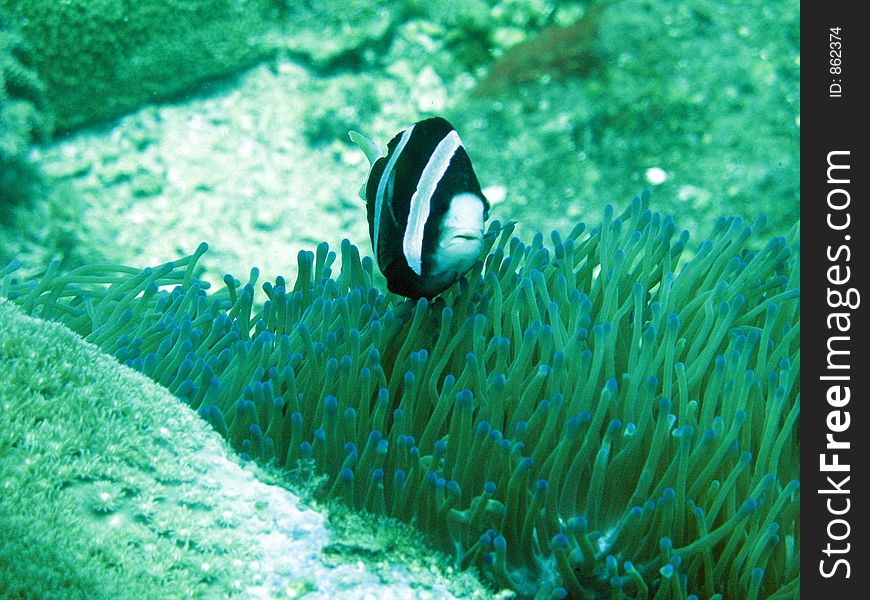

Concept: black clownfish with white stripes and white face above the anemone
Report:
left=349, top=117, right=490, bottom=298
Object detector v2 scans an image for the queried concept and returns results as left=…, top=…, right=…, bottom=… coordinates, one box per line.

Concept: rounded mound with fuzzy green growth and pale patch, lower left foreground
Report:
left=0, top=299, right=488, bottom=600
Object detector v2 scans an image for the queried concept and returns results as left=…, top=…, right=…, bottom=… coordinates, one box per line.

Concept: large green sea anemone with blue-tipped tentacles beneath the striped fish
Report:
left=0, top=195, right=800, bottom=598
